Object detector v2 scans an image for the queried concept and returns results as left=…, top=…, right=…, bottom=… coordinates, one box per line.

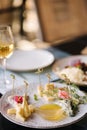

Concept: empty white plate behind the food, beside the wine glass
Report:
left=7, top=49, right=54, bottom=71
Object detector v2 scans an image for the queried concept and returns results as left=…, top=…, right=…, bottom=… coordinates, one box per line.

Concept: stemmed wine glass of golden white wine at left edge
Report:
left=0, top=25, right=14, bottom=86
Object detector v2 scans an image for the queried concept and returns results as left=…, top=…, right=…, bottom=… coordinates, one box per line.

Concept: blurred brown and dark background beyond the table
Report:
left=0, top=0, right=87, bottom=54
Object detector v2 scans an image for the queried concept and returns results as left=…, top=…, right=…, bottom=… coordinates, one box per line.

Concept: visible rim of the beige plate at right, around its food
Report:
left=52, top=55, right=87, bottom=86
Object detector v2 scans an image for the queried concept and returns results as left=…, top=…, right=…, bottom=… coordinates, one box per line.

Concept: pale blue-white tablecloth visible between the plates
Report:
left=0, top=47, right=69, bottom=94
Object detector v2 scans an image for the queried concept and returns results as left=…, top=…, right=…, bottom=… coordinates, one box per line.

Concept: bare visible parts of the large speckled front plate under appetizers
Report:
left=0, top=83, right=87, bottom=129
